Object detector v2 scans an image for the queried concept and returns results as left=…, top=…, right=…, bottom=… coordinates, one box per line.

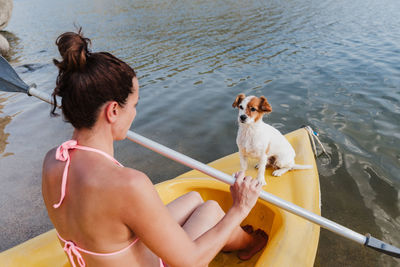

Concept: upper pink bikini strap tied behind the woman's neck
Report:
left=53, top=140, right=123, bottom=209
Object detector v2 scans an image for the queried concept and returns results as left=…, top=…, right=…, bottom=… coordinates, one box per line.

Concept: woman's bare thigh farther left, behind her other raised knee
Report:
left=167, top=191, right=204, bottom=225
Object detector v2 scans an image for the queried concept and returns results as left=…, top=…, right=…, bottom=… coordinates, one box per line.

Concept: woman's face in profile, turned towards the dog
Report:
left=118, top=77, right=139, bottom=140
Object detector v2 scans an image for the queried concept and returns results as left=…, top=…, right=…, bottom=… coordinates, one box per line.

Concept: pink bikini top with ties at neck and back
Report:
left=53, top=140, right=138, bottom=267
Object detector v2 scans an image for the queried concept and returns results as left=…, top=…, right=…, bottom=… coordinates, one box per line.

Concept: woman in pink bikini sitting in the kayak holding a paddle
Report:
left=42, top=30, right=267, bottom=266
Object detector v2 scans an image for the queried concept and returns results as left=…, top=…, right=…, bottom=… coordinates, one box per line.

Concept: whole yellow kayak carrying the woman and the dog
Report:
left=0, top=129, right=321, bottom=267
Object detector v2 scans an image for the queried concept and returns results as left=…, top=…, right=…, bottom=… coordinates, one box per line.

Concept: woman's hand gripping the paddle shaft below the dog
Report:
left=230, top=171, right=262, bottom=218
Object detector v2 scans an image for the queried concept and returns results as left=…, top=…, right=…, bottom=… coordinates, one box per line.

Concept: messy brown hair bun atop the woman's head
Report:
left=53, top=28, right=91, bottom=71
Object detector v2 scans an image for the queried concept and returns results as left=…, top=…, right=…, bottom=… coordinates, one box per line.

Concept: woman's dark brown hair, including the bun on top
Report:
left=51, top=28, right=136, bottom=129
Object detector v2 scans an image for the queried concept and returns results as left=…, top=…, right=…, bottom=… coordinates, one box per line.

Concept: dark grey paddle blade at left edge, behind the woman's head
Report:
left=0, top=56, right=29, bottom=93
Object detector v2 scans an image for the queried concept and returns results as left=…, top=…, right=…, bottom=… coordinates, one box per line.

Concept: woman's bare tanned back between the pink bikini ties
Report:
left=42, top=149, right=158, bottom=266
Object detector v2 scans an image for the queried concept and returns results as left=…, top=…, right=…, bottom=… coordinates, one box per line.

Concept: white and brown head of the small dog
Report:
left=232, top=94, right=272, bottom=124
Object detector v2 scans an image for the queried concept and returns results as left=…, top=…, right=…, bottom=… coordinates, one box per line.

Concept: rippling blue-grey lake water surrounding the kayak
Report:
left=0, top=0, right=400, bottom=267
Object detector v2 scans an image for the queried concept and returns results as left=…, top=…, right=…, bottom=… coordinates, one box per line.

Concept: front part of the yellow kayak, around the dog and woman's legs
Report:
left=161, top=129, right=321, bottom=267
